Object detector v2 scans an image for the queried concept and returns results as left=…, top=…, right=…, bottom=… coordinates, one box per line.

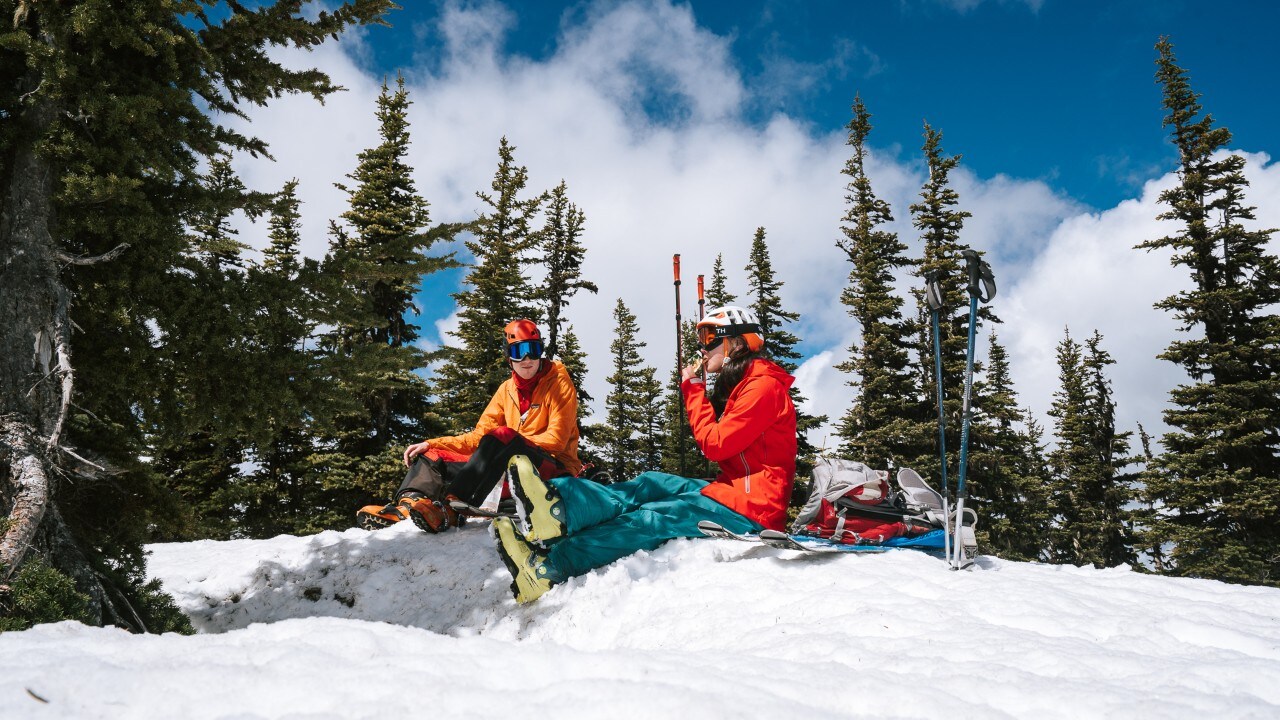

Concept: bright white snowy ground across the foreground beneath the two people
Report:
left=0, top=515, right=1280, bottom=720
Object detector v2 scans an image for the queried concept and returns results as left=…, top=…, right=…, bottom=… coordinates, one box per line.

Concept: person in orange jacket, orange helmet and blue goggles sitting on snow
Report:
left=356, top=319, right=582, bottom=533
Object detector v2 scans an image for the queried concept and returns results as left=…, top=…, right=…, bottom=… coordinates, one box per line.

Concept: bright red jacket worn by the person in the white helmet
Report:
left=680, top=360, right=796, bottom=530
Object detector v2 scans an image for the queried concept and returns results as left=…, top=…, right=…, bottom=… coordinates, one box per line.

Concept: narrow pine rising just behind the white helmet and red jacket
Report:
left=746, top=228, right=827, bottom=479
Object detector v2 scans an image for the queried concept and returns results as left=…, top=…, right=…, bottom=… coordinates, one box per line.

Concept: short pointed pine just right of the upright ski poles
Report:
left=966, top=334, right=1050, bottom=560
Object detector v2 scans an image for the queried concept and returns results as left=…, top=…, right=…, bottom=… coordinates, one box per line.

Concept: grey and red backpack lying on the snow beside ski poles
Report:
left=791, top=457, right=943, bottom=544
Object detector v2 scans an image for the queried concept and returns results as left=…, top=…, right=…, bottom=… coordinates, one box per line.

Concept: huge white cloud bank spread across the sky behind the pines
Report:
left=225, top=0, right=1280, bottom=458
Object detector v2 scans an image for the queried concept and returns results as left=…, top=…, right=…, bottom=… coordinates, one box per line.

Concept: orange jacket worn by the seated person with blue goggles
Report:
left=428, top=360, right=582, bottom=475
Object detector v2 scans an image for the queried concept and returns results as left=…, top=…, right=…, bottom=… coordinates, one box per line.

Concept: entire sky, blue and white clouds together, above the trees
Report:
left=228, top=0, right=1280, bottom=446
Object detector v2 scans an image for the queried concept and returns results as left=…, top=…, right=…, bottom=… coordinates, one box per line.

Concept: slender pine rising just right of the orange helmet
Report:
left=539, top=181, right=599, bottom=357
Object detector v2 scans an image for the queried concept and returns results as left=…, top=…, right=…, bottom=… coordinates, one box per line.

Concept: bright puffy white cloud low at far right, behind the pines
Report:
left=998, top=154, right=1280, bottom=447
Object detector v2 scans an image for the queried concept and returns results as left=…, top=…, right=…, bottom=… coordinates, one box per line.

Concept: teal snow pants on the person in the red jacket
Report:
left=543, top=473, right=762, bottom=583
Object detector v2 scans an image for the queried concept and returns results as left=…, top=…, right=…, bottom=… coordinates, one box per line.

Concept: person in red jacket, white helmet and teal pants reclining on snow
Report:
left=493, top=306, right=796, bottom=603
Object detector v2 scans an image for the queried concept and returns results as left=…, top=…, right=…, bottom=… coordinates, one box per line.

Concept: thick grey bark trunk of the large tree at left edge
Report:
left=0, top=76, right=124, bottom=629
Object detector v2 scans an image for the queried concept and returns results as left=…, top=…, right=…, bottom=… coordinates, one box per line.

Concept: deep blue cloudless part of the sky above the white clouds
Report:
left=374, top=0, right=1280, bottom=208
